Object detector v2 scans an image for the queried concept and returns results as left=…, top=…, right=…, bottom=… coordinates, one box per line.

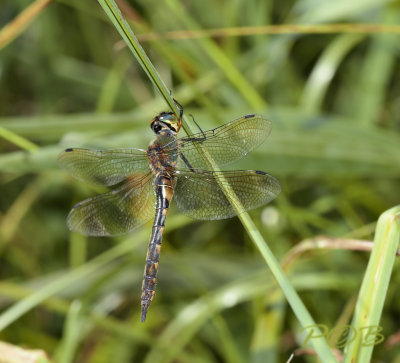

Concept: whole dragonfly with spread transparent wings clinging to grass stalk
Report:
left=58, top=103, right=281, bottom=322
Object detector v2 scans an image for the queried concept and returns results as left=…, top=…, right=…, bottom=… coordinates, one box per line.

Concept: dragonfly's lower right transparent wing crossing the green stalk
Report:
left=174, top=170, right=281, bottom=219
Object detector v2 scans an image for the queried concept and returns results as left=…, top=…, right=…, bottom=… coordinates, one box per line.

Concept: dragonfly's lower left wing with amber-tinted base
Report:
left=67, top=173, right=156, bottom=236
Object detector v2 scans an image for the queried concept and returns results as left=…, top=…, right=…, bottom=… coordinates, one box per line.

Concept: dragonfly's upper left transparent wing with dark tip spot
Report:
left=58, top=148, right=149, bottom=186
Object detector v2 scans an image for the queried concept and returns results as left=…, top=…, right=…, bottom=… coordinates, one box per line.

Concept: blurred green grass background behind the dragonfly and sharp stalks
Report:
left=0, top=0, right=400, bottom=363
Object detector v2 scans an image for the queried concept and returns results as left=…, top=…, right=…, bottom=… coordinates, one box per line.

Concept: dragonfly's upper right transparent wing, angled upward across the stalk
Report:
left=172, top=115, right=271, bottom=169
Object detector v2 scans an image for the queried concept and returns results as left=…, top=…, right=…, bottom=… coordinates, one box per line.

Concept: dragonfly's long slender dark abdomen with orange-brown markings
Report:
left=141, top=175, right=173, bottom=322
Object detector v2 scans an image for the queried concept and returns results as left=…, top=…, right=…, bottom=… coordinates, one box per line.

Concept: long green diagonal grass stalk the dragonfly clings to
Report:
left=98, top=0, right=336, bottom=362
